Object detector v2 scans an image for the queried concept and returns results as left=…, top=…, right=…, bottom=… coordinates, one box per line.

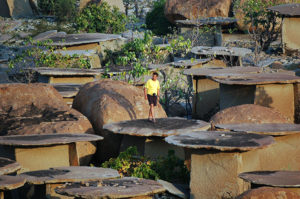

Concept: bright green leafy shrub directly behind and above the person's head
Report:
left=104, top=32, right=191, bottom=83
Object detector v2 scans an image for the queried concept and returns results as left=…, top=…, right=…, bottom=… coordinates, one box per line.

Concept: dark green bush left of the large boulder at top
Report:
left=146, top=0, right=175, bottom=35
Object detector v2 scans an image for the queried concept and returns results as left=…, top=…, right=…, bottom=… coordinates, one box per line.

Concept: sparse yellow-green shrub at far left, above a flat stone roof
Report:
left=9, top=39, right=91, bottom=81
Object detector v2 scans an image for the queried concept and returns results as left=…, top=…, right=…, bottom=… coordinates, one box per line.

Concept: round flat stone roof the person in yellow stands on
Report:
left=103, top=117, right=210, bottom=137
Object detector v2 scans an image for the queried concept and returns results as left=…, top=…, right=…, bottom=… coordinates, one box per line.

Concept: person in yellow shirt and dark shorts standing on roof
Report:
left=144, top=72, right=160, bottom=122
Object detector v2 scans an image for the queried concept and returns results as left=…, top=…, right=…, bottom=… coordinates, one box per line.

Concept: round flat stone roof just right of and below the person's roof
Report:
left=165, top=131, right=275, bottom=151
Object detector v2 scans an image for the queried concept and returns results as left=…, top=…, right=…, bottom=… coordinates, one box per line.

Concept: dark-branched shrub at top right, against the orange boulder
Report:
left=234, top=0, right=283, bottom=50
